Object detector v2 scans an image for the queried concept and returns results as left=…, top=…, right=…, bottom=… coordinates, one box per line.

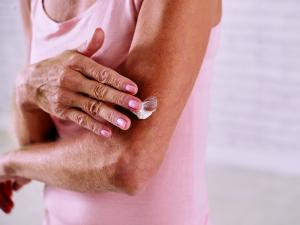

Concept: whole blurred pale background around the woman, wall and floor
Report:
left=0, top=0, right=300, bottom=225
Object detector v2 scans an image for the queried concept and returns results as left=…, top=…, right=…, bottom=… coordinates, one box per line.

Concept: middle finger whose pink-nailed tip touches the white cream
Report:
left=66, top=71, right=142, bottom=111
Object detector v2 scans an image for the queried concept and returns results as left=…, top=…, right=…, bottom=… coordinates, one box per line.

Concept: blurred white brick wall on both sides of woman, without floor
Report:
left=0, top=0, right=300, bottom=174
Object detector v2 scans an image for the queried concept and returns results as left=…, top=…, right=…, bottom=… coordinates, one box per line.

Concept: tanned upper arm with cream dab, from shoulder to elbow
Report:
left=116, top=0, right=220, bottom=193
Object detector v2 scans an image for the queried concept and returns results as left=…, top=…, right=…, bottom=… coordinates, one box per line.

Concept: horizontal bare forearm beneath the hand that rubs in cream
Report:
left=8, top=128, right=130, bottom=192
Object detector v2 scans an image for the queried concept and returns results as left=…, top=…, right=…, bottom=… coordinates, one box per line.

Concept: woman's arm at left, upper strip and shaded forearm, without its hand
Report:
left=13, top=0, right=55, bottom=146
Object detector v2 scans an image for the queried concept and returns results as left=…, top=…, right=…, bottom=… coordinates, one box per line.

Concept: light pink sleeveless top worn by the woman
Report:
left=31, top=0, right=219, bottom=225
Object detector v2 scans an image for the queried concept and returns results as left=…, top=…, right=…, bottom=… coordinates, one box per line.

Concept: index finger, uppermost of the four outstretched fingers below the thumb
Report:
left=70, top=53, right=138, bottom=94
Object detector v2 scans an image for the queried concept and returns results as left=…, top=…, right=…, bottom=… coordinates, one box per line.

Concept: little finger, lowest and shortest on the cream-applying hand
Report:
left=65, top=108, right=112, bottom=138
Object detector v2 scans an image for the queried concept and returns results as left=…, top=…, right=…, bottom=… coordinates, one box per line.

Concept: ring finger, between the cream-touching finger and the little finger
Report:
left=70, top=93, right=131, bottom=130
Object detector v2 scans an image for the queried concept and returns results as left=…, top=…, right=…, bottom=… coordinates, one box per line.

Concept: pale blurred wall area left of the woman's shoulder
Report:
left=0, top=0, right=25, bottom=118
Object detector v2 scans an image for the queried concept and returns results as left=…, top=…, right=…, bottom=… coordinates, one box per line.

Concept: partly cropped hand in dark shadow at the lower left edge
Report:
left=0, top=155, right=30, bottom=214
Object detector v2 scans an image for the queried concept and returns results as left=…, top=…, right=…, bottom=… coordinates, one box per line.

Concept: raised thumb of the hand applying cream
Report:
left=77, top=28, right=104, bottom=57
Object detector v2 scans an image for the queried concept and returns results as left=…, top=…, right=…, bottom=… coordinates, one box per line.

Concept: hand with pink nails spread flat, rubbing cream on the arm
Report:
left=16, top=29, right=141, bottom=137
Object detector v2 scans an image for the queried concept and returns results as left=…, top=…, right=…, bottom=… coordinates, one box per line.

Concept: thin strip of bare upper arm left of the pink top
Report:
left=20, top=0, right=31, bottom=63
